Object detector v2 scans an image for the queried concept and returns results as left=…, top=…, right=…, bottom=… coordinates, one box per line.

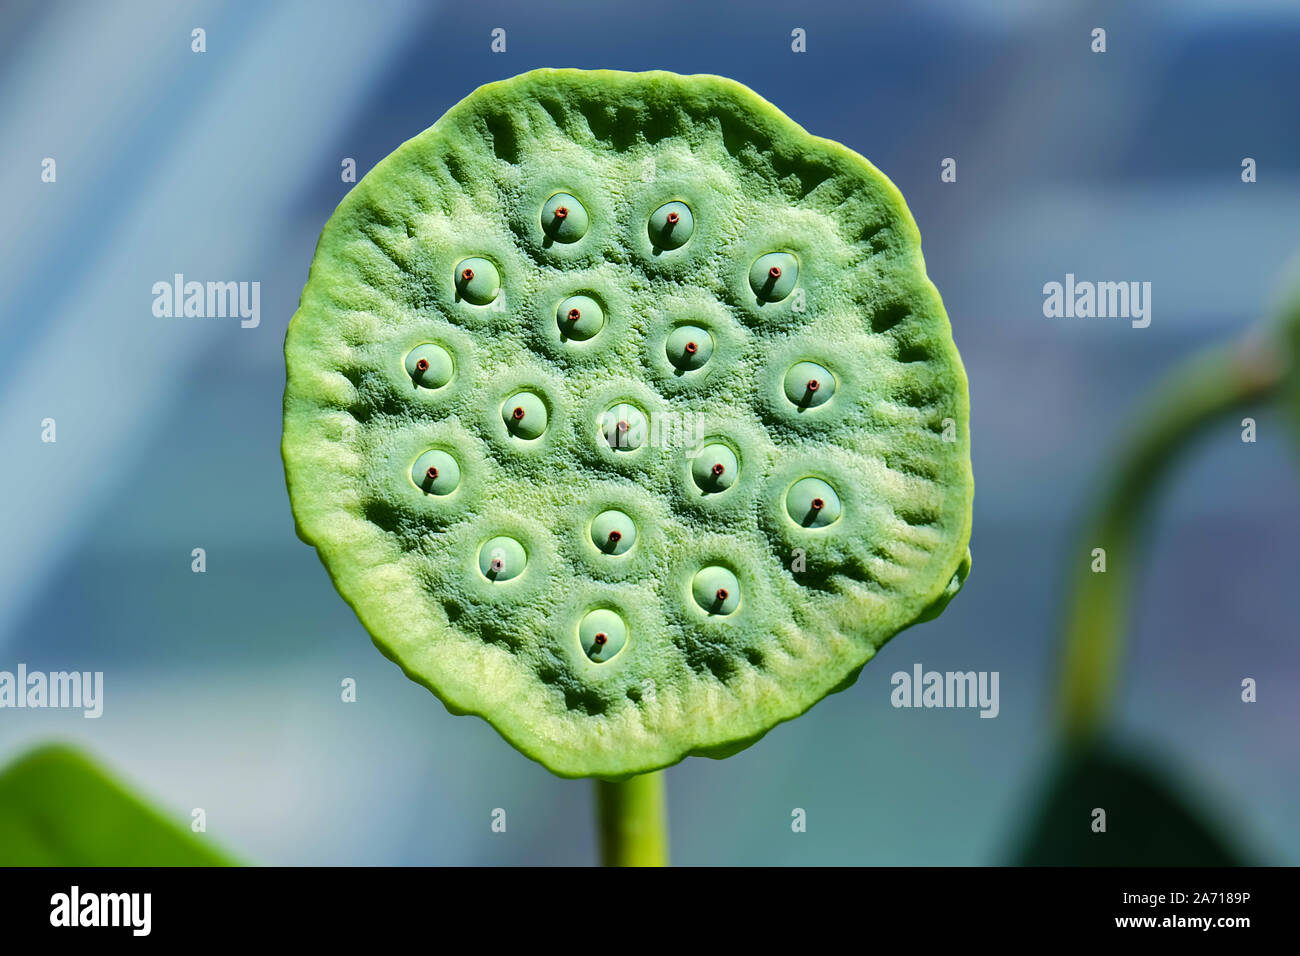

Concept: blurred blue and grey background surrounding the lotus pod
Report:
left=0, top=0, right=1300, bottom=864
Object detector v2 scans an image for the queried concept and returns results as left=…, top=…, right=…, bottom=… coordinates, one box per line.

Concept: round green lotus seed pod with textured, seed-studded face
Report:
left=282, top=70, right=972, bottom=778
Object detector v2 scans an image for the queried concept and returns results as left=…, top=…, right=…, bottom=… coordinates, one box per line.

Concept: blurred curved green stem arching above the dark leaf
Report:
left=1060, top=339, right=1284, bottom=744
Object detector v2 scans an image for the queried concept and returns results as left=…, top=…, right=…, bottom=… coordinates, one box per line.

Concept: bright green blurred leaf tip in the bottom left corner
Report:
left=0, top=747, right=234, bottom=866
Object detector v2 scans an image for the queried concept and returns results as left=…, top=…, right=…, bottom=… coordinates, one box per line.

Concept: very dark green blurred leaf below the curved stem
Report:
left=1013, top=744, right=1247, bottom=866
